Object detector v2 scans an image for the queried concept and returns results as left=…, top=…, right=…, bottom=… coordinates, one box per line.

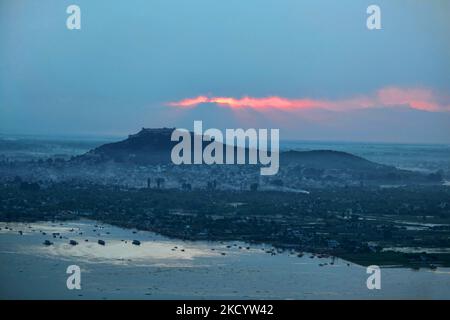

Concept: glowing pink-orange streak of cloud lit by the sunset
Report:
left=167, top=87, right=450, bottom=111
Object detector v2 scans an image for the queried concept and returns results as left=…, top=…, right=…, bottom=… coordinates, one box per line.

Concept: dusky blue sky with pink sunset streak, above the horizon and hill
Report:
left=0, top=0, right=450, bottom=143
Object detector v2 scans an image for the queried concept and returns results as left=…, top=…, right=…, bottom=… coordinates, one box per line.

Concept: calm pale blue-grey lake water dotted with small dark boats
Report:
left=0, top=220, right=450, bottom=299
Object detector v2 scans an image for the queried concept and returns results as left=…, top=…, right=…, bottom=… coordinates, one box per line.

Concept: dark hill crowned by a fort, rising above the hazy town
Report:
left=72, top=128, right=441, bottom=184
